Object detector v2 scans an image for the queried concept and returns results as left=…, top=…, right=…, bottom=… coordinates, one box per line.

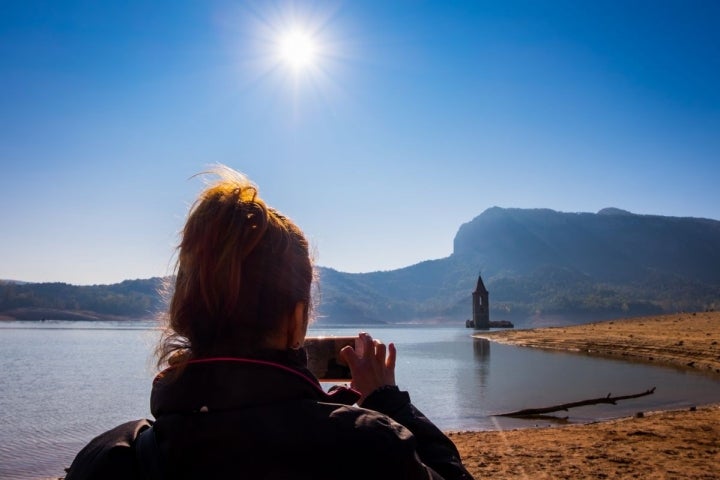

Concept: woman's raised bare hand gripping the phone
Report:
left=340, top=332, right=397, bottom=405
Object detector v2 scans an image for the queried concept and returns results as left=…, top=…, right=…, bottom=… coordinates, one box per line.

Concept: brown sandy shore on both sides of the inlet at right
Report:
left=450, top=312, right=720, bottom=479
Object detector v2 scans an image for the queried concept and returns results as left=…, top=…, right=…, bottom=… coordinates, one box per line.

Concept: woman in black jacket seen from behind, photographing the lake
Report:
left=66, top=167, right=472, bottom=480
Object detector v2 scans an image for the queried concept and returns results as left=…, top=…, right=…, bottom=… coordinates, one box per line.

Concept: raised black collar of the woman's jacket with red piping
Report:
left=150, top=350, right=360, bottom=418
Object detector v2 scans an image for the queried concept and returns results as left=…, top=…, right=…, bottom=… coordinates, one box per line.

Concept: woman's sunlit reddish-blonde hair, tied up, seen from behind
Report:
left=156, top=165, right=313, bottom=366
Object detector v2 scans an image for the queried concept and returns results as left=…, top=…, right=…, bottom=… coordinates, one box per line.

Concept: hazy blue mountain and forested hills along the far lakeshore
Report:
left=0, top=207, right=720, bottom=325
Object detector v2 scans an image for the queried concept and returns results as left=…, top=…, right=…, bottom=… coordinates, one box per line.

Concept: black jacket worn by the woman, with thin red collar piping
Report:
left=66, top=352, right=472, bottom=480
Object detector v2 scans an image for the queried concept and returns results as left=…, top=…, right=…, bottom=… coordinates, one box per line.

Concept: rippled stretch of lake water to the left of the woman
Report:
left=0, top=321, right=157, bottom=479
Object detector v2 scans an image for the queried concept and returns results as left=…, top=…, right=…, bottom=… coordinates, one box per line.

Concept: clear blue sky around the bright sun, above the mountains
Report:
left=0, top=0, right=720, bottom=284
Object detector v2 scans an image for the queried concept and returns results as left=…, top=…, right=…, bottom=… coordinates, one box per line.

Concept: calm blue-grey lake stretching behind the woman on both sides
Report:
left=0, top=321, right=720, bottom=479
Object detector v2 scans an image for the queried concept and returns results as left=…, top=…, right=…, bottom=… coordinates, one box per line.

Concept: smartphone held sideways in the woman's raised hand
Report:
left=304, top=337, right=357, bottom=382
